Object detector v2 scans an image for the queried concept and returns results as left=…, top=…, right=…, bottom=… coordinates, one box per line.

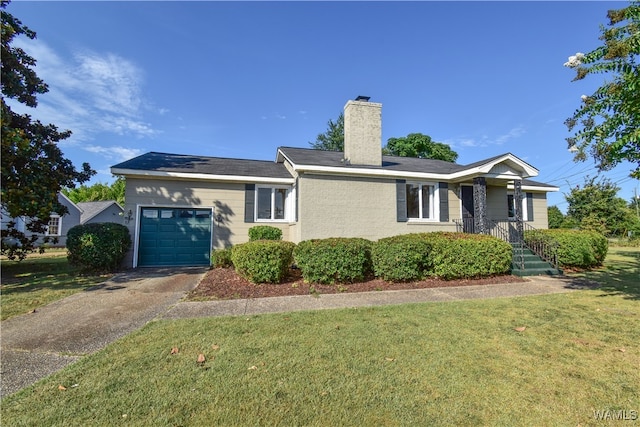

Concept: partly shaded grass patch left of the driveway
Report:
left=0, top=249, right=110, bottom=320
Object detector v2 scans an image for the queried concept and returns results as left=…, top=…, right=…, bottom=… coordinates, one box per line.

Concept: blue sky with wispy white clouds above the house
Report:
left=7, top=0, right=640, bottom=210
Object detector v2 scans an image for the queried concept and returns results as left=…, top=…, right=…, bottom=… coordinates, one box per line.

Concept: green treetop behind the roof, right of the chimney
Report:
left=383, top=133, right=458, bottom=163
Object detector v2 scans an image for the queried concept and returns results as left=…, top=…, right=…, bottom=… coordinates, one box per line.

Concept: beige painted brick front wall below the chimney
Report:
left=298, top=174, right=457, bottom=240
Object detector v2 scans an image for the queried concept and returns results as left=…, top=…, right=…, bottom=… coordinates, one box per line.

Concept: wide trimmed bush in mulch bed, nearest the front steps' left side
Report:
left=422, top=232, right=512, bottom=280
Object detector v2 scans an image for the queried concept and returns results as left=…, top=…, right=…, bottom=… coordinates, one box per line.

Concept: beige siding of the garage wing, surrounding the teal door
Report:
left=124, top=177, right=290, bottom=265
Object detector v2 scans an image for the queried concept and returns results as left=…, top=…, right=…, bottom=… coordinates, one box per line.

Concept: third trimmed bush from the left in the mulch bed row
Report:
left=371, top=234, right=431, bottom=282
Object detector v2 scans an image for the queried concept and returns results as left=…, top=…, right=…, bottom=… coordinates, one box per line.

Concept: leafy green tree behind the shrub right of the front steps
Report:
left=565, top=177, right=640, bottom=236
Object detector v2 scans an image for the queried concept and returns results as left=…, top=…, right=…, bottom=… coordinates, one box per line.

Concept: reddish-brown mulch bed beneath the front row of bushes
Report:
left=188, top=268, right=526, bottom=300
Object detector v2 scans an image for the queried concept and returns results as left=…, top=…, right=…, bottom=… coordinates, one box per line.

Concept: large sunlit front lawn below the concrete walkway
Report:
left=1, top=248, right=640, bottom=426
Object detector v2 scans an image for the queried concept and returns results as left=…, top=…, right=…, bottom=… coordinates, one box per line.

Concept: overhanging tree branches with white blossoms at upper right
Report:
left=564, top=1, right=640, bottom=179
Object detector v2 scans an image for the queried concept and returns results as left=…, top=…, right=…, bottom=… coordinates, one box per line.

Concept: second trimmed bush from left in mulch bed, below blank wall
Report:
left=293, top=238, right=372, bottom=284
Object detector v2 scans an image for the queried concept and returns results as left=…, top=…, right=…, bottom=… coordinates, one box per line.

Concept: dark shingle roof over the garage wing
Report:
left=112, top=152, right=291, bottom=178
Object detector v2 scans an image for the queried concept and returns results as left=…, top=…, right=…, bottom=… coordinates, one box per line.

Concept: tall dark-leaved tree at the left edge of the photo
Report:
left=0, top=0, right=95, bottom=259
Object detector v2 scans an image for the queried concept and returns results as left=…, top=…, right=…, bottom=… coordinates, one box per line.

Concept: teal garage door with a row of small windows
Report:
left=138, top=208, right=211, bottom=267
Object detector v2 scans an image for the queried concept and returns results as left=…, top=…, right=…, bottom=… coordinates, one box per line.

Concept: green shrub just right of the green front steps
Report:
left=524, top=229, right=609, bottom=268
